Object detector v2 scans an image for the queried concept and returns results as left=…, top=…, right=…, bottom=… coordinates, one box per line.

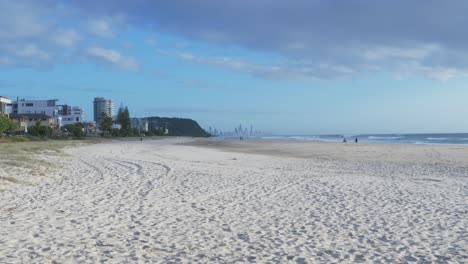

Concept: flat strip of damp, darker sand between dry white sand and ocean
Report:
left=183, top=138, right=468, bottom=167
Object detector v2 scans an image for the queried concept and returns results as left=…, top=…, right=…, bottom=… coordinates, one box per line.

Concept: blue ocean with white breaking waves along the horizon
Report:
left=225, top=133, right=468, bottom=145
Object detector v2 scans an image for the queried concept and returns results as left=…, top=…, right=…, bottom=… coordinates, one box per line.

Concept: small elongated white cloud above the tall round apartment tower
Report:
left=86, top=47, right=139, bottom=71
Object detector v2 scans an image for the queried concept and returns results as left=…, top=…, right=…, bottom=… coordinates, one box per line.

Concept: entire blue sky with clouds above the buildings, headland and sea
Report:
left=0, top=0, right=468, bottom=135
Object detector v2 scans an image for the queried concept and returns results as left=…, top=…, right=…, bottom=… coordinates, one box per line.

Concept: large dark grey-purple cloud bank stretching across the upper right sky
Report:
left=66, top=0, right=468, bottom=78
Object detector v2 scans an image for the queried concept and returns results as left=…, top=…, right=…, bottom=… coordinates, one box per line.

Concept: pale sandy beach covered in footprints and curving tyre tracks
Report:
left=0, top=139, right=468, bottom=263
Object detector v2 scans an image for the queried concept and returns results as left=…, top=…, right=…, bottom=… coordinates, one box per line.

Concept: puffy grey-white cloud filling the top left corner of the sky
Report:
left=0, top=0, right=80, bottom=68
